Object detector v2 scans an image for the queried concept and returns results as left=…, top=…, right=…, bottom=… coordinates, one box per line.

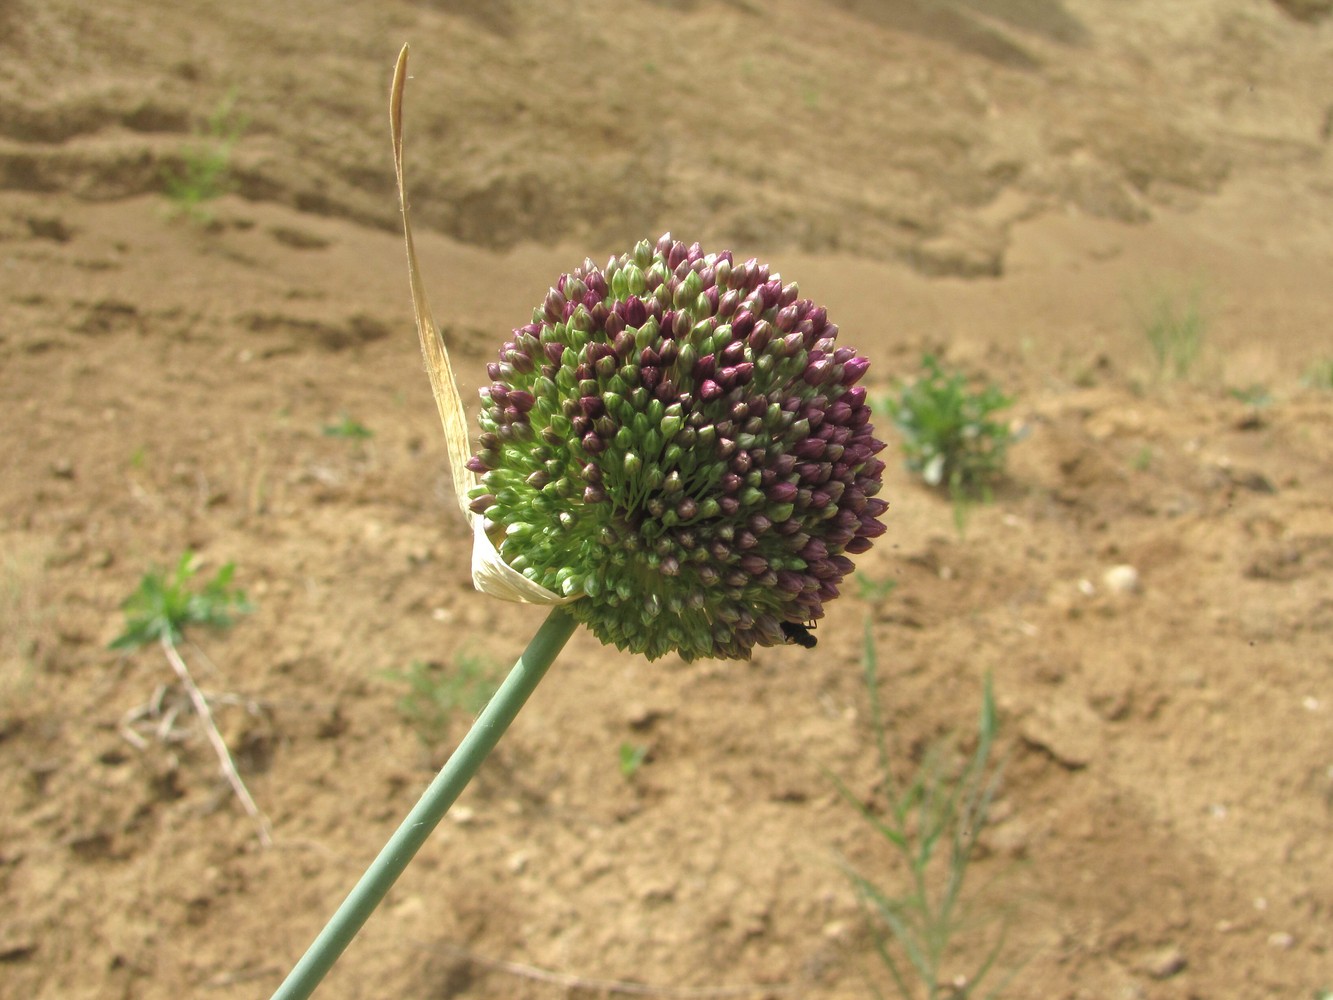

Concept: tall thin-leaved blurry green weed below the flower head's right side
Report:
left=837, top=624, right=1013, bottom=1000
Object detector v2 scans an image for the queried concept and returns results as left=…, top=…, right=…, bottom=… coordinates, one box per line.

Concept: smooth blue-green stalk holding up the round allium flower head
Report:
left=273, top=607, right=579, bottom=1000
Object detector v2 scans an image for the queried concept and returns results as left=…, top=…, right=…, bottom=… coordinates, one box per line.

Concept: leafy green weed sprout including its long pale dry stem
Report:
left=111, top=552, right=273, bottom=847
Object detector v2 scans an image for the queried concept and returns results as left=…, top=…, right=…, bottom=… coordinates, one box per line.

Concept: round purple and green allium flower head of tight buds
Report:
left=468, top=235, right=888, bottom=660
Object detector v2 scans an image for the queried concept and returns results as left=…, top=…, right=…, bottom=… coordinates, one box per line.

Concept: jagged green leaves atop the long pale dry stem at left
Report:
left=111, top=552, right=251, bottom=649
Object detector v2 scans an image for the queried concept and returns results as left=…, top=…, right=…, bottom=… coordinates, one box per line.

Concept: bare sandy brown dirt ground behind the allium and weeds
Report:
left=0, top=0, right=1333, bottom=1000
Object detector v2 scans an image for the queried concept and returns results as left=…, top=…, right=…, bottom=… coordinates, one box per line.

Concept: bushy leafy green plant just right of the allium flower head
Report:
left=884, top=355, right=1017, bottom=503
